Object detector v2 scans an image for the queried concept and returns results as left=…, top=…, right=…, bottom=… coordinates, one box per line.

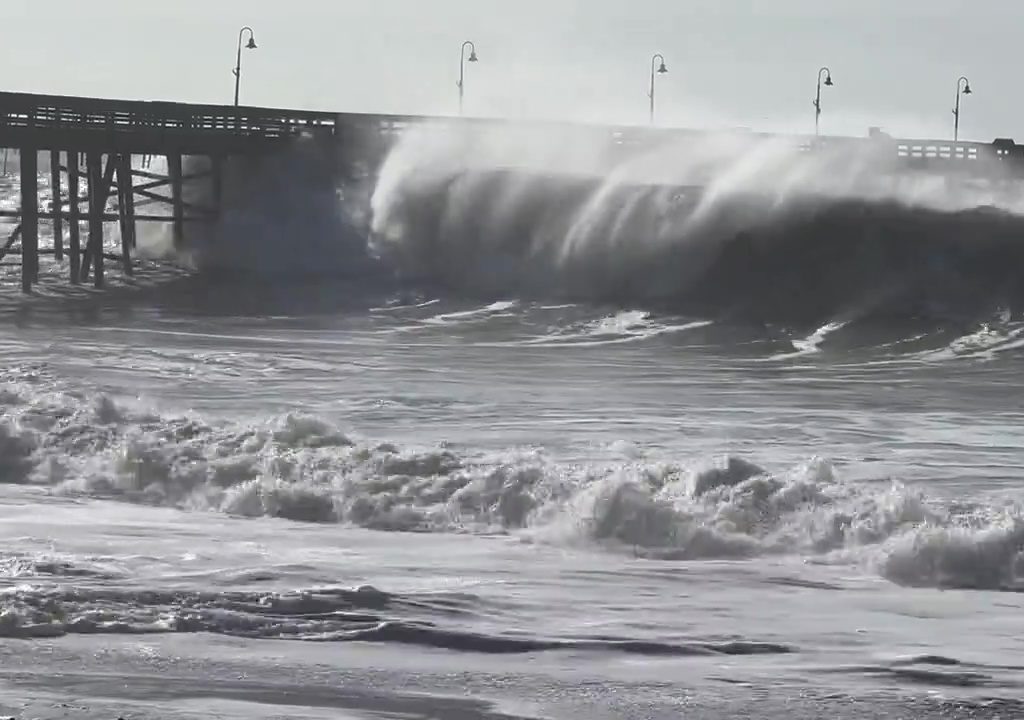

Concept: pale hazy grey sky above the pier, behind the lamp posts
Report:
left=8, top=0, right=1024, bottom=141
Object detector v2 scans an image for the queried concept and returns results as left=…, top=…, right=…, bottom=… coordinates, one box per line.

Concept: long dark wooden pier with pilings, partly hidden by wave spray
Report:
left=0, top=92, right=1024, bottom=292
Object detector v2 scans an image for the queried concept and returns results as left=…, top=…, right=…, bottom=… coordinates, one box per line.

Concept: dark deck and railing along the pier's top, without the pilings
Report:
left=0, top=92, right=1024, bottom=175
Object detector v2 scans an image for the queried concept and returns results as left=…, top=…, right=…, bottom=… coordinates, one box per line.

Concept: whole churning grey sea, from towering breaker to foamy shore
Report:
left=0, top=126, right=1024, bottom=720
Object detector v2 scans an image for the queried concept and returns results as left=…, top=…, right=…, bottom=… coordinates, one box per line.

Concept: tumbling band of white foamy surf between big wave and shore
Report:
left=0, top=374, right=1024, bottom=590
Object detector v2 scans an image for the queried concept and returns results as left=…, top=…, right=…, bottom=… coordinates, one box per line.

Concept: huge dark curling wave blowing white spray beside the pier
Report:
left=373, top=123, right=1024, bottom=325
